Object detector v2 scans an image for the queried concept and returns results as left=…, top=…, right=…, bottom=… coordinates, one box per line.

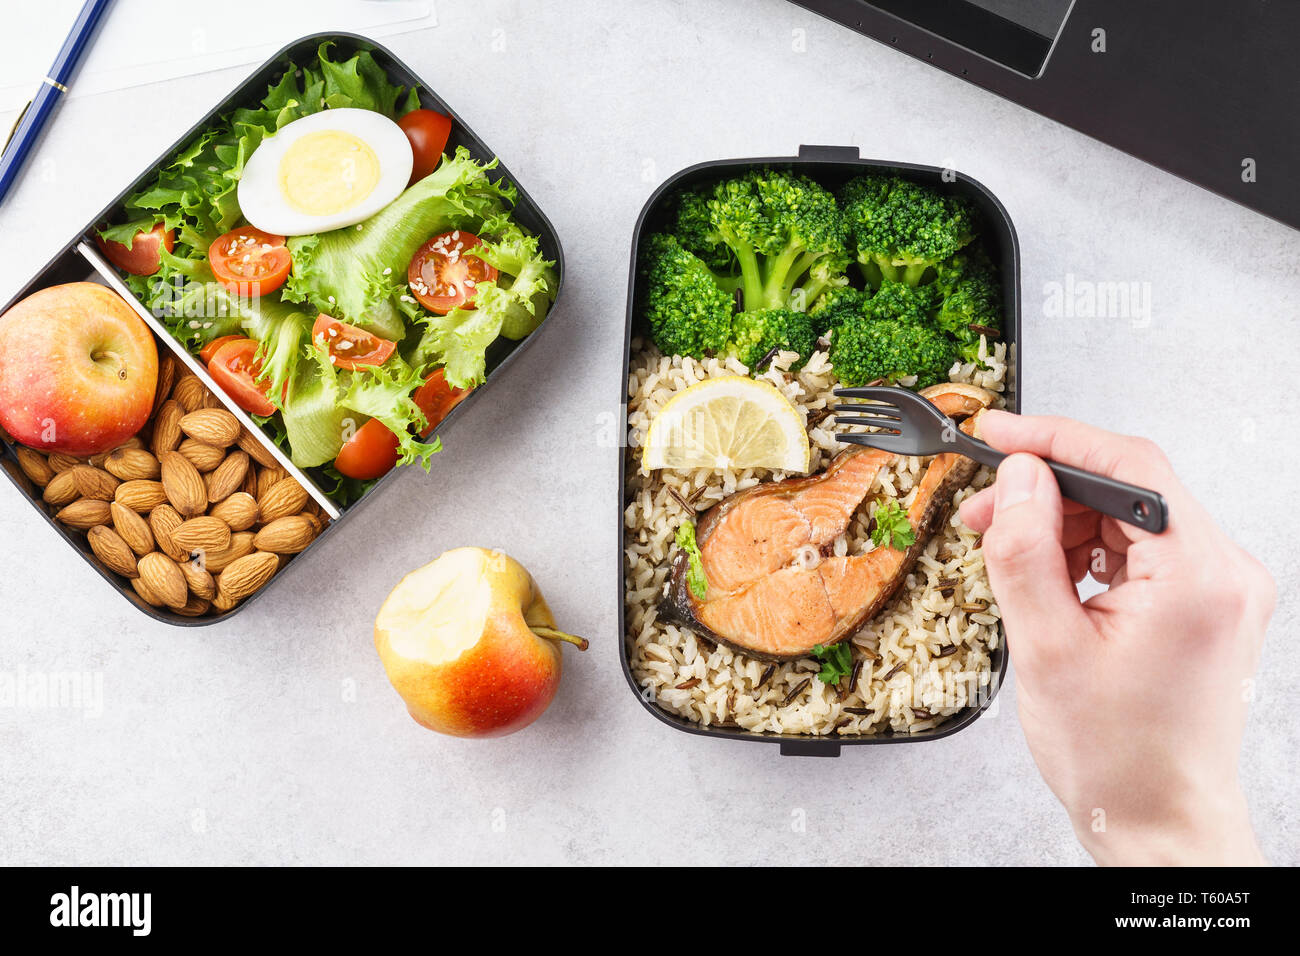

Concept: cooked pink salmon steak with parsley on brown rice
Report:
left=660, top=384, right=995, bottom=661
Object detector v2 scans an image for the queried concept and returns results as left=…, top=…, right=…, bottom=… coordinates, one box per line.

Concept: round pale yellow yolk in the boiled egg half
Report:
left=280, top=130, right=380, bottom=216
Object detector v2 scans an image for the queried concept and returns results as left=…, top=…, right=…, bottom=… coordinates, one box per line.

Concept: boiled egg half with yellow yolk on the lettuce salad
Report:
left=237, top=108, right=412, bottom=235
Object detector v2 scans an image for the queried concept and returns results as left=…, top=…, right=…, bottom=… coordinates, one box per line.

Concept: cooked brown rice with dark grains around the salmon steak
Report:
left=624, top=341, right=1008, bottom=735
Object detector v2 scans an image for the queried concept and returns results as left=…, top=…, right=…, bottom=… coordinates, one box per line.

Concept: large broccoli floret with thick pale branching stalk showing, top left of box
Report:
left=707, top=169, right=850, bottom=312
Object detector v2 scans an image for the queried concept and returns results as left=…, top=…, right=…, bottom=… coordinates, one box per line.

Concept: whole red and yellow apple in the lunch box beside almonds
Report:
left=0, top=282, right=159, bottom=455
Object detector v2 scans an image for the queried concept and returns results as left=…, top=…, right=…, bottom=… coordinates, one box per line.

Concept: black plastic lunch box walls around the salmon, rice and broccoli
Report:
left=619, top=146, right=1021, bottom=757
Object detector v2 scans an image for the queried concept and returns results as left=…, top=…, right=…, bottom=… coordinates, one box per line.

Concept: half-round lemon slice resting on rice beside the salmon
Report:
left=641, top=375, right=809, bottom=472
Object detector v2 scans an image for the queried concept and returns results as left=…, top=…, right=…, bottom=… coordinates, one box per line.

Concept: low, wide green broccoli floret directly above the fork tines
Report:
left=831, top=316, right=957, bottom=389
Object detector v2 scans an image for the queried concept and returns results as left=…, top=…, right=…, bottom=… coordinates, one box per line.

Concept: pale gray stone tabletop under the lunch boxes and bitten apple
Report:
left=0, top=0, right=1300, bottom=864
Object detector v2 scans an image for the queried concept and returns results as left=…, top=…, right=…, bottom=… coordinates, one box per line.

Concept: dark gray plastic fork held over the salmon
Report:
left=831, top=386, right=1169, bottom=535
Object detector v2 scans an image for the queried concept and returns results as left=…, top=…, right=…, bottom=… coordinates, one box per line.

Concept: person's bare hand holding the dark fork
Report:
left=961, top=411, right=1274, bottom=864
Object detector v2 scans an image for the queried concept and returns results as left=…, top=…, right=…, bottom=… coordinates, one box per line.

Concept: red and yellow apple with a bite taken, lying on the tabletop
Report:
left=374, top=548, right=586, bottom=737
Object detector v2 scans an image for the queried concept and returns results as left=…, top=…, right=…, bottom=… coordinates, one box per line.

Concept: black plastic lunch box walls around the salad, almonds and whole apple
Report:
left=0, top=33, right=564, bottom=627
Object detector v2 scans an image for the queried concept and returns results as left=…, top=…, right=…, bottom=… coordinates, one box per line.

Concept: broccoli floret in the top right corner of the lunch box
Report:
left=840, top=173, right=975, bottom=286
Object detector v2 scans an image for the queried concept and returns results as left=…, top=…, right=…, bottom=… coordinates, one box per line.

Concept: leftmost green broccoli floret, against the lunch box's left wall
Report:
left=640, top=233, right=735, bottom=359
